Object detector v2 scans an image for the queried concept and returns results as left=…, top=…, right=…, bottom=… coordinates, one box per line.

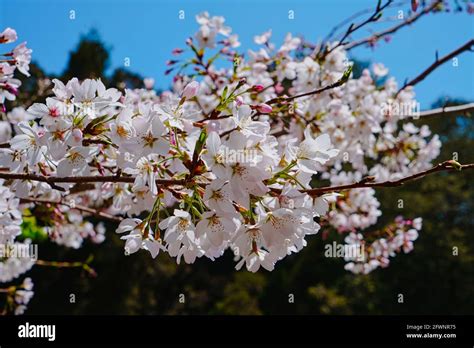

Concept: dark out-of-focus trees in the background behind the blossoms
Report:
left=18, top=31, right=474, bottom=315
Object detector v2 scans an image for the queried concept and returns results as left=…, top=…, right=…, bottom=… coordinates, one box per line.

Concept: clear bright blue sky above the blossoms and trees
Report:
left=0, top=0, right=474, bottom=109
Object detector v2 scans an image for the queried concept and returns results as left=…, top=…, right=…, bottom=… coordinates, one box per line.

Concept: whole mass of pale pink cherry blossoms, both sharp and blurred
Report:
left=0, top=13, right=441, bottom=308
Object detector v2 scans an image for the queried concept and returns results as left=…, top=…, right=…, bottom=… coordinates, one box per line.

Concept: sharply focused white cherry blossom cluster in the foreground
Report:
left=1, top=75, right=338, bottom=271
